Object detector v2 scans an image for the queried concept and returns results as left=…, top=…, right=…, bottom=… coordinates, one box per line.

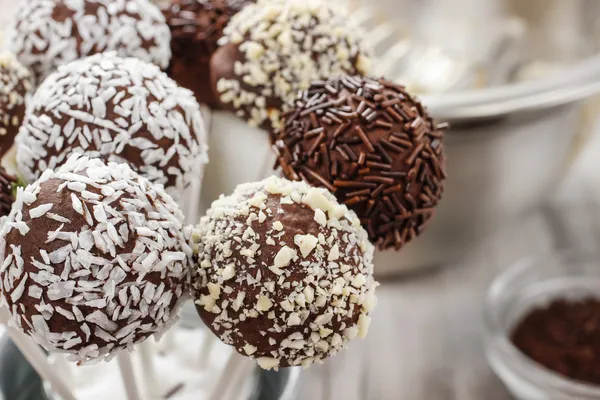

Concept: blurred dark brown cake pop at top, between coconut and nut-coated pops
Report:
left=162, top=0, right=254, bottom=106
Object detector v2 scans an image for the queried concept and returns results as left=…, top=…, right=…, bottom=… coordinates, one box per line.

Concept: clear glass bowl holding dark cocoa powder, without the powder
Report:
left=485, top=251, right=600, bottom=400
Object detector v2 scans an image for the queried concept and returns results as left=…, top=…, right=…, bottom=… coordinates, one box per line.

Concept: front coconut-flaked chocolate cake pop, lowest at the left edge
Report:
left=0, top=156, right=191, bottom=361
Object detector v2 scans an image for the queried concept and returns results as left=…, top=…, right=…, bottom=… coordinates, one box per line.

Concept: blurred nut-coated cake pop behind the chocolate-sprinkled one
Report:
left=211, top=0, right=369, bottom=130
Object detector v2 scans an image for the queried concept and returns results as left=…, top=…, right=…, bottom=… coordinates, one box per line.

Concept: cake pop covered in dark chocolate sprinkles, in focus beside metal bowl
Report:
left=274, top=76, right=446, bottom=250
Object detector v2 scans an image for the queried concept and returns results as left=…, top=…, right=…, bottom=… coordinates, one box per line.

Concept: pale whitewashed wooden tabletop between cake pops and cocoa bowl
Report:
left=299, top=123, right=600, bottom=400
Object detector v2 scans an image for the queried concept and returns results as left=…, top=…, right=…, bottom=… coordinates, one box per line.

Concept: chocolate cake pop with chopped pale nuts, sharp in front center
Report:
left=192, top=177, right=377, bottom=369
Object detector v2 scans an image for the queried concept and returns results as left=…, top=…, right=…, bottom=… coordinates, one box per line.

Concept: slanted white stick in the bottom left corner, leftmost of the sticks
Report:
left=0, top=307, right=76, bottom=400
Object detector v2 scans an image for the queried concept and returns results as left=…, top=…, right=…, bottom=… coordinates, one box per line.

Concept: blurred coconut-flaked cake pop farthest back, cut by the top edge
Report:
left=10, top=0, right=171, bottom=83
